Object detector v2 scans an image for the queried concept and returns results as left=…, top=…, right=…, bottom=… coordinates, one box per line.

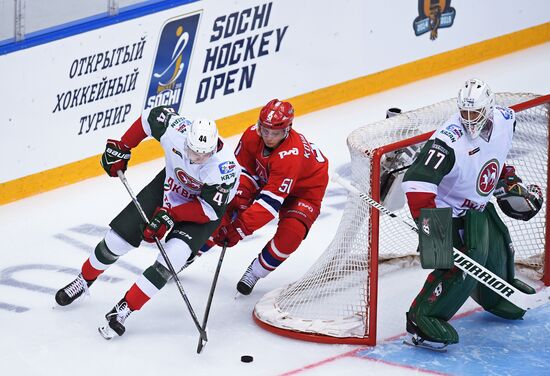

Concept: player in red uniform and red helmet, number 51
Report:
left=208, top=99, right=328, bottom=295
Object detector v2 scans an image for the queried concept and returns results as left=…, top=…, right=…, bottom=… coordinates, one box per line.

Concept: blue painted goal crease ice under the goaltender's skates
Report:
left=357, top=304, right=550, bottom=376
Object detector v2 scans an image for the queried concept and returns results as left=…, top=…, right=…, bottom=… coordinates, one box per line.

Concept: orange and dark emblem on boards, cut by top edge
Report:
left=413, top=0, right=456, bottom=40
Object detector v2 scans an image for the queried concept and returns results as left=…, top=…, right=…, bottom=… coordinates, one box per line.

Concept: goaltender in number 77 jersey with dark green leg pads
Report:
left=402, top=79, right=542, bottom=344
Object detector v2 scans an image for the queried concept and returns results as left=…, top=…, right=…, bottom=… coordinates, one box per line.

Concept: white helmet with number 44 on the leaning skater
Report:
left=187, top=119, right=218, bottom=163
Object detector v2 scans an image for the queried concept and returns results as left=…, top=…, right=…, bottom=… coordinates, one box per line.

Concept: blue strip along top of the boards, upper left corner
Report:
left=0, top=0, right=200, bottom=55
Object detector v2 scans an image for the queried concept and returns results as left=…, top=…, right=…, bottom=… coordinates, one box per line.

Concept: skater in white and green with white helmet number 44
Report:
left=55, top=106, right=241, bottom=336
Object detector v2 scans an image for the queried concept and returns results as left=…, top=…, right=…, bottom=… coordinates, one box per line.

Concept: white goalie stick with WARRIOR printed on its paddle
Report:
left=332, top=174, right=550, bottom=310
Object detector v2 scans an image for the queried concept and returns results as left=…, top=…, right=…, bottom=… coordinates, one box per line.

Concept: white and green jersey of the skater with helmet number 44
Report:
left=141, top=107, right=241, bottom=221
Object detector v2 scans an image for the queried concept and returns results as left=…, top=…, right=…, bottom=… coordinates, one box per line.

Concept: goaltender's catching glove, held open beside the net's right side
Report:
left=495, top=182, right=544, bottom=221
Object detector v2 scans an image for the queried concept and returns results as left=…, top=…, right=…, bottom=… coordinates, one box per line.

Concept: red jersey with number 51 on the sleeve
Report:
left=235, top=125, right=328, bottom=231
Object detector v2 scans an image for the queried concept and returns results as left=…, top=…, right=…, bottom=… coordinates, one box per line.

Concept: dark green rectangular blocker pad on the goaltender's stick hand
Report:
left=418, top=208, right=453, bottom=269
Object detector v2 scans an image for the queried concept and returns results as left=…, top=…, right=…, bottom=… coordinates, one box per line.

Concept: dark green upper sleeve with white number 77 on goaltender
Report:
left=403, top=138, right=455, bottom=185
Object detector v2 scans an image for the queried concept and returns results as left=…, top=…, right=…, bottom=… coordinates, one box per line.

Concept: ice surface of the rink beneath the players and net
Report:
left=0, top=43, right=550, bottom=376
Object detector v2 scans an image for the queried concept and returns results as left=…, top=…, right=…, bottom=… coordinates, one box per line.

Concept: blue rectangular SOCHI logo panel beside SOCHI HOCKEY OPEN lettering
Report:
left=145, top=13, right=200, bottom=111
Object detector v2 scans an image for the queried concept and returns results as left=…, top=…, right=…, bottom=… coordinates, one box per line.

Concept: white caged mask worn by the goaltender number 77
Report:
left=457, top=78, right=495, bottom=139
